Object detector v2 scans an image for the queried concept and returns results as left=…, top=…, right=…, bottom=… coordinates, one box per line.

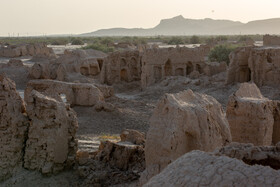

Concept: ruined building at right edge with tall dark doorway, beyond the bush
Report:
left=226, top=46, right=280, bottom=86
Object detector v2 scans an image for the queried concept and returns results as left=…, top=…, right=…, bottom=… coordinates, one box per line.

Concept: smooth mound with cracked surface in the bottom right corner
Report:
left=144, top=151, right=280, bottom=187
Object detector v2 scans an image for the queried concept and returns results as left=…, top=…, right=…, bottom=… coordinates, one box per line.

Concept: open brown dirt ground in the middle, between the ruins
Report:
left=74, top=73, right=280, bottom=151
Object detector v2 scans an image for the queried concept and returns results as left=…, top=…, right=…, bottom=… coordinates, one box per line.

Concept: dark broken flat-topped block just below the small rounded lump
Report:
left=96, top=141, right=145, bottom=173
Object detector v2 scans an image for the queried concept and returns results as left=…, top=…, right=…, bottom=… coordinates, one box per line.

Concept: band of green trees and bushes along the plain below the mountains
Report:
left=0, top=35, right=254, bottom=57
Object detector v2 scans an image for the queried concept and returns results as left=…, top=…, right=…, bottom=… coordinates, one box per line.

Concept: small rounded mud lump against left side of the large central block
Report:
left=120, top=129, right=145, bottom=146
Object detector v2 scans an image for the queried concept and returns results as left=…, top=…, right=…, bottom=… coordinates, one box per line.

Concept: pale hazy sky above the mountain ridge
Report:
left=0, top=0, right=280, bottom=36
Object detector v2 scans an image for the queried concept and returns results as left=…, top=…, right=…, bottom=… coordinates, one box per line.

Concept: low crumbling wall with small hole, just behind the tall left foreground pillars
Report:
left=24, top=80, right=104, bottom=106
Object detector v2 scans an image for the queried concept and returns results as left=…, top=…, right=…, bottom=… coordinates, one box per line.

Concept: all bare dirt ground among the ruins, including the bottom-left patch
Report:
left=0, top=50, right=280, bottom=187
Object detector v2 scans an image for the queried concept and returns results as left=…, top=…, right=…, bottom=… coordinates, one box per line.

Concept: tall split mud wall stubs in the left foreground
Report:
left=0, top=76, right=78, bottom=181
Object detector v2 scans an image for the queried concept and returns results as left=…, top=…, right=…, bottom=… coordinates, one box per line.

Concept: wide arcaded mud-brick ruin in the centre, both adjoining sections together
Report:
left=101, top=46, right=210, bottom=88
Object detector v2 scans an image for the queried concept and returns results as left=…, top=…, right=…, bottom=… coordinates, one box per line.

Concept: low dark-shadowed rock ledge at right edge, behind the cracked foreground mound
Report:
left=214, top=143, right=280, bottom=170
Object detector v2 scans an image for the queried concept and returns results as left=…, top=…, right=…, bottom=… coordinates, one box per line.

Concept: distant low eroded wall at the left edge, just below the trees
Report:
left=0, top=43, right=55, bottom=58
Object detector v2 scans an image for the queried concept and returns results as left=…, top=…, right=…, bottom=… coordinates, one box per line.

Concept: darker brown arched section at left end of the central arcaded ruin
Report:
left=101, top=50, right=141, bottom=85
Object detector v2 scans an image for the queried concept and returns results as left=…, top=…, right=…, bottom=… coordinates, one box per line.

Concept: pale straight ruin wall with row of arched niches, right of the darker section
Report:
left=141, top=46, right=210, bottom=88
